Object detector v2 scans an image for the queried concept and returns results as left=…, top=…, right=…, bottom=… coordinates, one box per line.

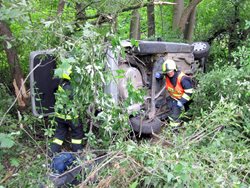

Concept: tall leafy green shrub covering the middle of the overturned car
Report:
left=55, top=24, right=132, bottom=146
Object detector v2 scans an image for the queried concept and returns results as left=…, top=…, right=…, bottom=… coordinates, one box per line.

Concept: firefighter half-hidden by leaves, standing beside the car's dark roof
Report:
left=50, top=66, right=83, bottom=154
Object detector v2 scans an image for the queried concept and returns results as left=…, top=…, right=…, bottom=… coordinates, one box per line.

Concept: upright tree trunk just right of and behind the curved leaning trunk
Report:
left=184, top=7, right=196, bottom=42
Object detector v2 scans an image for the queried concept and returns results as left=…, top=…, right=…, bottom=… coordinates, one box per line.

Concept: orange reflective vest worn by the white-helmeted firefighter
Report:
left=166, top=72, right=185, bottom=99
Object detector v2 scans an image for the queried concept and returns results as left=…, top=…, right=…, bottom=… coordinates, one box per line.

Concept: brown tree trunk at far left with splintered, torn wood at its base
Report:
left=0, top=21, right=29, bottom=109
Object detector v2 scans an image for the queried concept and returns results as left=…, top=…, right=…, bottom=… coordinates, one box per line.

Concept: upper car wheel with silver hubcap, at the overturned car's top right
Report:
left=192, top=42, right=210, bottom=59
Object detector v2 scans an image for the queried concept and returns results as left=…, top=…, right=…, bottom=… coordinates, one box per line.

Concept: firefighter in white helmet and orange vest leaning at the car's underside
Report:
left=155, top=59, right=193, bottom=126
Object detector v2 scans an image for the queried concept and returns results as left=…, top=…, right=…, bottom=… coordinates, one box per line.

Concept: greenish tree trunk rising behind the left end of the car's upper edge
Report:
left=130, top=9, right=141, bottom=40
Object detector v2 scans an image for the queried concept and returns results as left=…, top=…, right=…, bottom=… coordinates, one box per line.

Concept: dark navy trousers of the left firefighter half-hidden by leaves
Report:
left=51, top=117, right=83, bottom=153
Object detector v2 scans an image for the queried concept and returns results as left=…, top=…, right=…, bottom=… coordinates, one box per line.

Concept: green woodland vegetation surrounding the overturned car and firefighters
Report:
left=0, top=0, right=250, bottom=188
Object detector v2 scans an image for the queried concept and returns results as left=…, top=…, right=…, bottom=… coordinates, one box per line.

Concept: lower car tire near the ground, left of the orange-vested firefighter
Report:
left=130, top=116, right=162, bottom=135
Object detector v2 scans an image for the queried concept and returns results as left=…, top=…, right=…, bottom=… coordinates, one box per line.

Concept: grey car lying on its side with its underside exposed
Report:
left=30, top=41, right=209, bottom=134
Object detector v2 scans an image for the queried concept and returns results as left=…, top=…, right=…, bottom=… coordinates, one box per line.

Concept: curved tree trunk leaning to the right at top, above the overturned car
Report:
left=179, top=0, right=202, bottom=32
